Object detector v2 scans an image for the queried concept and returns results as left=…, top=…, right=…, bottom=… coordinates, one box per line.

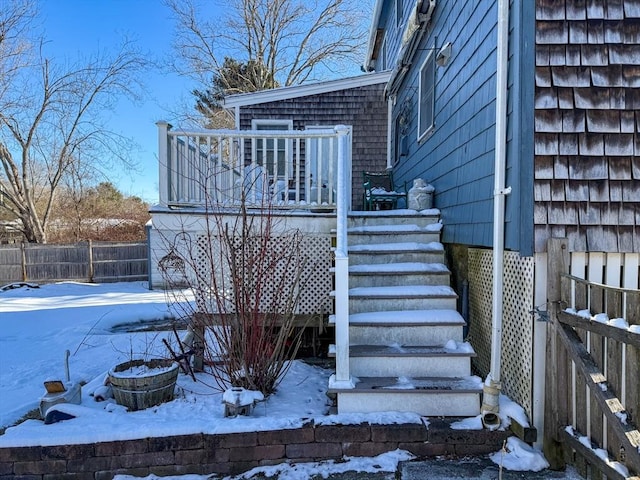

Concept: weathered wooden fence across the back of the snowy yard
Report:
left=0, top=241, right=148, bottom=286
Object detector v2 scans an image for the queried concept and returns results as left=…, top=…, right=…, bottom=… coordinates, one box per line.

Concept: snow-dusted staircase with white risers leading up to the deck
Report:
left=329, top=210, right=482, bottom=416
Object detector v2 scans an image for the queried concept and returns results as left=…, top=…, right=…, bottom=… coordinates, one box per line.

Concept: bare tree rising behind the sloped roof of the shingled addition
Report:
left=166, top=0, right=369, bottom=91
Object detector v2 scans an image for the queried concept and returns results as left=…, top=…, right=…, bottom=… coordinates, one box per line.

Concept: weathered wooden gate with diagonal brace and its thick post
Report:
left=544, top=239, right=640, bottom=480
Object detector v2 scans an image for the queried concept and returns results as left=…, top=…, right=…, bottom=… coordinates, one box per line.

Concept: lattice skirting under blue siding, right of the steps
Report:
left=469, top=248, right=535, bottom=418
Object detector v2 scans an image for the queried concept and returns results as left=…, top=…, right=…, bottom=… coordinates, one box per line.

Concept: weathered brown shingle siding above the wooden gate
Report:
left=534, top=0, right=640, bottom=252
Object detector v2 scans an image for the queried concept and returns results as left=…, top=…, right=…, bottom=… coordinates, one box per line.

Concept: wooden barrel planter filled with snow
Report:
left=109, top=359, right=178, bottom=411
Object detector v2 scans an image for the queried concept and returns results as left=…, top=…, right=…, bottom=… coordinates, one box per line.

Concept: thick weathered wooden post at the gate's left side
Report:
left=543, top=238, right=569, bottom=470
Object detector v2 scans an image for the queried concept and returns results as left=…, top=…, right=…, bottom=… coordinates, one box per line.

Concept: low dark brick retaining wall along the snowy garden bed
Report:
left=0, top=419, right=511, bottom=480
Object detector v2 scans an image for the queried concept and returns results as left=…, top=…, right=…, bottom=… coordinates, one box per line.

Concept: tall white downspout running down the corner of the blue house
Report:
left=482, top=0, right=511, bottom=430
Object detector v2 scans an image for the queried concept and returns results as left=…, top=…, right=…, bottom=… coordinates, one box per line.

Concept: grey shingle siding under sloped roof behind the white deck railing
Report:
left=240, top=83, right=387, bottom=209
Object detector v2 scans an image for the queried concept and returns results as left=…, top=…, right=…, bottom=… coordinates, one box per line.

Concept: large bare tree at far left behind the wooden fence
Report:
left=0, top=0, right=147, bottom=242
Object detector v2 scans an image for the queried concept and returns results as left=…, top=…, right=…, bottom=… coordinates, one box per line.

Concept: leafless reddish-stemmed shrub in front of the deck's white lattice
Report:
left=159, top=179, right=324, bottom=395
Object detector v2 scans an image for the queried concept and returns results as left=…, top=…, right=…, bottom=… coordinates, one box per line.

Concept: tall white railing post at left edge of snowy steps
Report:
left=330, top=125, right=354, bottom=388
